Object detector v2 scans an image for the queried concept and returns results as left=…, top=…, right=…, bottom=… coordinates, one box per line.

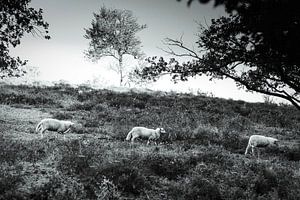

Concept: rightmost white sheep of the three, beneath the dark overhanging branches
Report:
left=245, top=135, right=278, bottom=158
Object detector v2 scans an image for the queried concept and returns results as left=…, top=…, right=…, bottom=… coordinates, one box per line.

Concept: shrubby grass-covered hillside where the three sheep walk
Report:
left=0, top=84, right=300, bottom=199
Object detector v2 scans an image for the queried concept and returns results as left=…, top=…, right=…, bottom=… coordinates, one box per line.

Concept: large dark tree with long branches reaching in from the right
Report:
left=137, top=0, right=300, bottom=110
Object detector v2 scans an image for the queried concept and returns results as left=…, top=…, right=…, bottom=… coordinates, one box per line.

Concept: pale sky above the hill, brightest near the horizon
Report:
left=11, top=0, right=263, bottom=102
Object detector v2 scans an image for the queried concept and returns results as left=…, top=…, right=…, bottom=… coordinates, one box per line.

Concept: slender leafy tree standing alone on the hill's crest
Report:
left=84, top=6, right=146, bottom=85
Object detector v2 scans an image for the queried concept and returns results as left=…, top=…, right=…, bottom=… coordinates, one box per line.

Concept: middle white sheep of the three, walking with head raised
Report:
left=126, top=127, right=166, bottom=145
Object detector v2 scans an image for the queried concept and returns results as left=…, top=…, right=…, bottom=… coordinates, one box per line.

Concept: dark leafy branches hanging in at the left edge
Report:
left=0, top=0, right=50, bottom=79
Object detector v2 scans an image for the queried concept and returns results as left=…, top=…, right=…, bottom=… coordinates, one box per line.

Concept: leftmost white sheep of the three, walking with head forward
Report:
left=35, top=118, right=75, bottom=139
